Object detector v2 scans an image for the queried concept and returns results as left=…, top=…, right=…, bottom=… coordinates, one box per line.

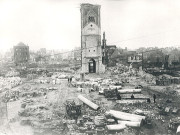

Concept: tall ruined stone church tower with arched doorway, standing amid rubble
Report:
left=81, top=4, right=105, bottom=73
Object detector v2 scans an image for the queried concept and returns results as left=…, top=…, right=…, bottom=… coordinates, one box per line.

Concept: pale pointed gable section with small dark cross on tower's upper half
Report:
left=83, top=22, right=100, bottom=35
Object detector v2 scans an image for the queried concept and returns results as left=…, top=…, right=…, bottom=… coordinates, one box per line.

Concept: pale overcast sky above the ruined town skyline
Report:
left=0, top=0, right=180, bottom=51
